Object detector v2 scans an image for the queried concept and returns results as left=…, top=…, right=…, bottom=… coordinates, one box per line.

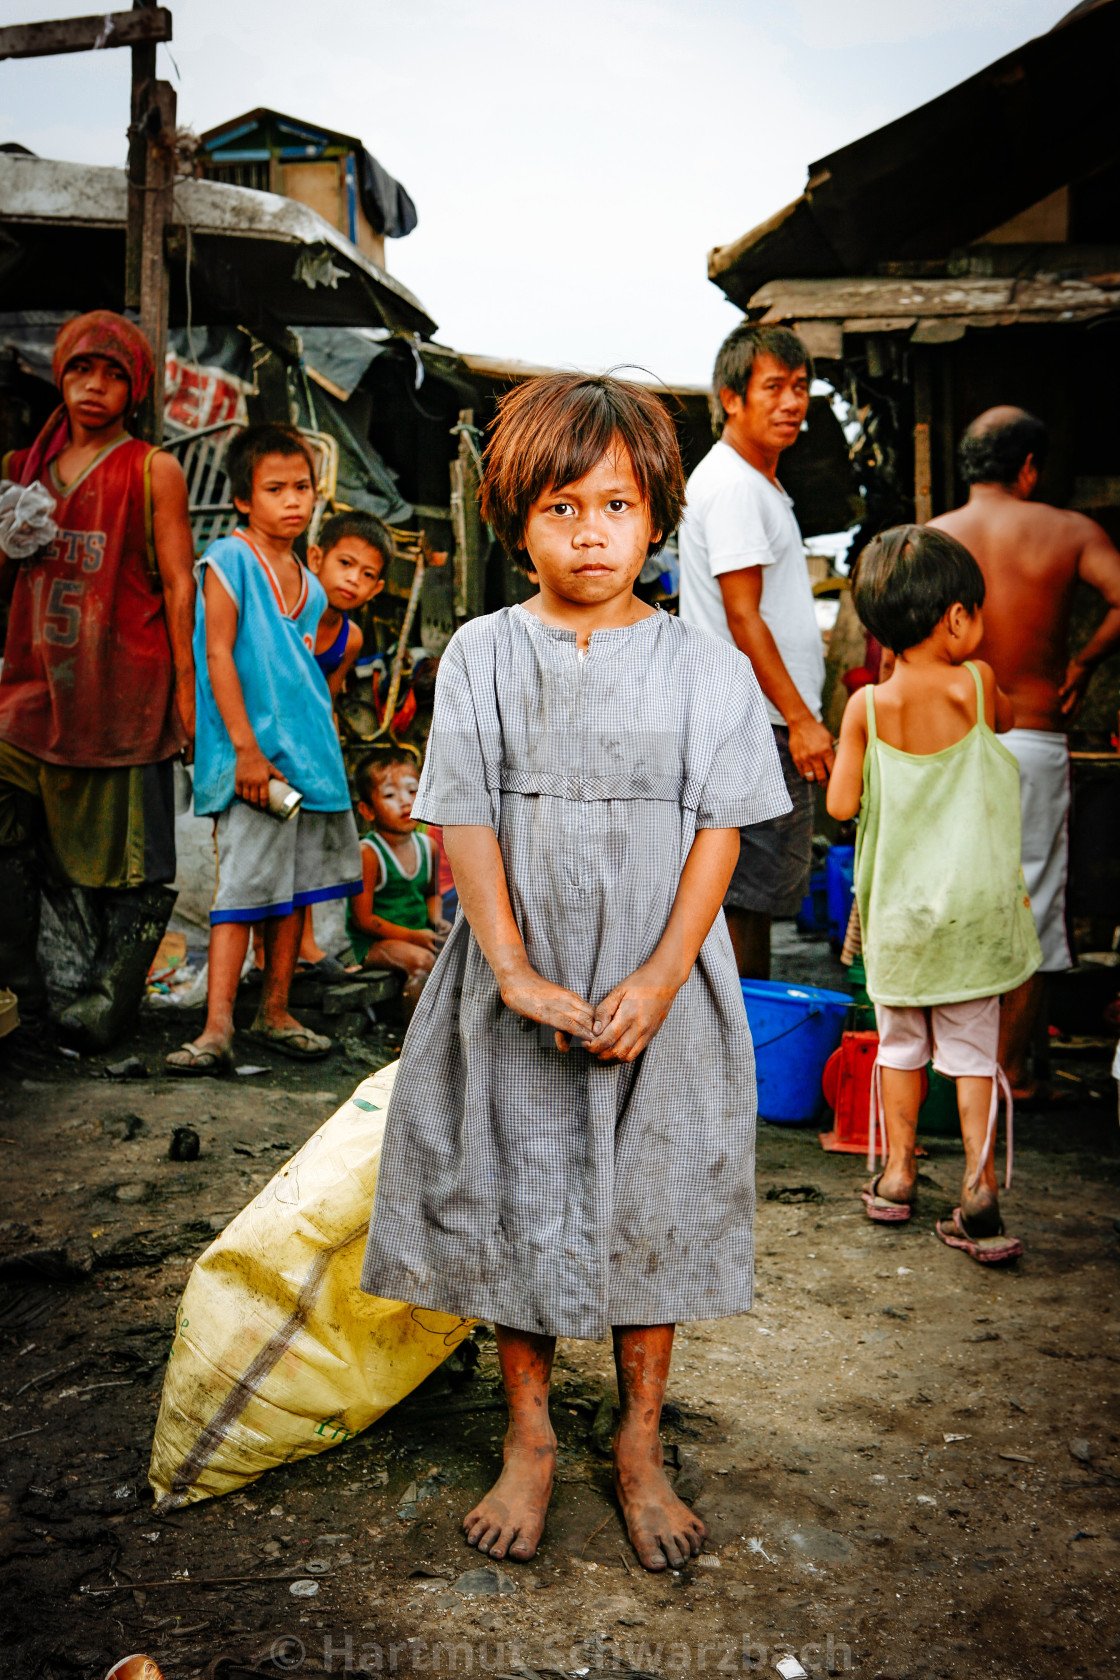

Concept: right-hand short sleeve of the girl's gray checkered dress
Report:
left=697, top=655, right=793, bottom=828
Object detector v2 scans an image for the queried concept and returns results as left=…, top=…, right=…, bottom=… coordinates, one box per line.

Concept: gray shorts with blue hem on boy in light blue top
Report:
left=210, top=800, right=361, bottom=926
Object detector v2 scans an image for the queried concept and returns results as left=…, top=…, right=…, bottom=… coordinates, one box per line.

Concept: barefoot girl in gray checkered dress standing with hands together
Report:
left=363, top=373, right=789, bottom=1569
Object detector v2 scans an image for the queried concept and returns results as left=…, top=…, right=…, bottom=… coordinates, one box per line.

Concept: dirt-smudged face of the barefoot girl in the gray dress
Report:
left=526, top=444, right=662, bottom=606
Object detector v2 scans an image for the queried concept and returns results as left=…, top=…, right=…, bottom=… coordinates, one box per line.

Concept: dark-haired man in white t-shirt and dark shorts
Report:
left=680, top=324, right=833, bottom=979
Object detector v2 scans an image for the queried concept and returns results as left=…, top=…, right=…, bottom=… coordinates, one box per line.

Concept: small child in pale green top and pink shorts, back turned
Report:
left=828, top=526, right=1041, bottom=1263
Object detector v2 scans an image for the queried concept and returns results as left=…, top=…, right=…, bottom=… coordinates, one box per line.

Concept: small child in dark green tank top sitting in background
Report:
left=346, top=748, right=452, bottom=1015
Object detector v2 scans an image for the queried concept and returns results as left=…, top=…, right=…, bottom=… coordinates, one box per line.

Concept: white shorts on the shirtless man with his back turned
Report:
left=999, top=729, right=1073, bottom=974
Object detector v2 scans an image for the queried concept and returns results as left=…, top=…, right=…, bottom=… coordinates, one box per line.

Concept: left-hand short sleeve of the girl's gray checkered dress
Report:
left=413, top=622, right=500, bottom=833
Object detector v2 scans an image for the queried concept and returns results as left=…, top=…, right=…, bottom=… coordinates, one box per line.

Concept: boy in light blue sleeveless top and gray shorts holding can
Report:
left=166, top=425, right=361, bottom=1075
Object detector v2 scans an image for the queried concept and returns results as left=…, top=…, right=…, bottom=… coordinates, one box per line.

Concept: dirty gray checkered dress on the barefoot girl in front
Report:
left=361, top=606, right=789, bottom=1339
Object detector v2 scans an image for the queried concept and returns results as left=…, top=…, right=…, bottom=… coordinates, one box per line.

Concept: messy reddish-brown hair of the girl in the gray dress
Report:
left=482, top=373, right=685, bottom=571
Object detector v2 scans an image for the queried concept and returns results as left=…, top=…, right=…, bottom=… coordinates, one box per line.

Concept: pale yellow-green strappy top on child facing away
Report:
left=855, top=660, right=1043, bottom=1008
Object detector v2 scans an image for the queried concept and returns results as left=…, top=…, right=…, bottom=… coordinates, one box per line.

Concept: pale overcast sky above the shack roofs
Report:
left=0, top=0, right=1073, bottom=385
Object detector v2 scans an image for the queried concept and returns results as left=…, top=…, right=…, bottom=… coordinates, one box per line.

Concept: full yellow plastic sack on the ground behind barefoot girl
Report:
left=148, top=1062, right=472, bottom=1510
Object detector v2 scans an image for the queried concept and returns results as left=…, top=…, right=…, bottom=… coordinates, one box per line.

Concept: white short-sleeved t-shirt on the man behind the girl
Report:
left=678, top=440, right=824, bottom=724
